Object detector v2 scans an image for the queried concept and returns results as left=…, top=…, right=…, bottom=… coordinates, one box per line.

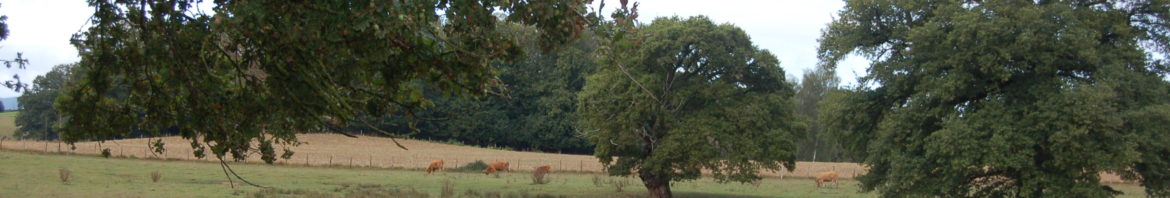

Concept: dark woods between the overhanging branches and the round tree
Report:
left=345, top=23, right=599, bottom=153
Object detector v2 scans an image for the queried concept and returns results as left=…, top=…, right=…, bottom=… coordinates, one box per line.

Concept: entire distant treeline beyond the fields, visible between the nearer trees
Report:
left=15, top=19, right=856, bottom=162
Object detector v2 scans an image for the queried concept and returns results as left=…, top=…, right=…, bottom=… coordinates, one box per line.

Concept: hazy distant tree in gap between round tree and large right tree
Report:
left=793, top=67, right=855, bottom=162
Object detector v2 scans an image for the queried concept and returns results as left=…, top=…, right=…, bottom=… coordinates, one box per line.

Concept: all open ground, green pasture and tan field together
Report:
left=0, top=114, right=1145, bottom=198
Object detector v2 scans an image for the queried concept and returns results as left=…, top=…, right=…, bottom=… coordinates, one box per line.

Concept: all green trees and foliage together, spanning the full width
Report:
left=0, top=0, right=1170, bottom=197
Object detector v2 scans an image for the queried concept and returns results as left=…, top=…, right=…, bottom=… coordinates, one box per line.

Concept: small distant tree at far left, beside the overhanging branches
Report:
left=13, top=64, right=75, bottom=141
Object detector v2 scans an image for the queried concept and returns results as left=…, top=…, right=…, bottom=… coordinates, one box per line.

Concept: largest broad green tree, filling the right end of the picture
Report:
left=819, top=0, right=1170, bottom=197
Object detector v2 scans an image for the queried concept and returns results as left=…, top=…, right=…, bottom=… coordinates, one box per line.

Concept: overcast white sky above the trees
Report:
left=0, top=0, right=867, bottom=97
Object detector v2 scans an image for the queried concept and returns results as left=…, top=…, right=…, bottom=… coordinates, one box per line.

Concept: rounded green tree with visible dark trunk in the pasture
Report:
left=578, top=16, right=804, bottom=197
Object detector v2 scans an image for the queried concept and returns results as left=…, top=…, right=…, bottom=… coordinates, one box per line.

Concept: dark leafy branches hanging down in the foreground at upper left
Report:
left=57, top=0, right=587, bottom=163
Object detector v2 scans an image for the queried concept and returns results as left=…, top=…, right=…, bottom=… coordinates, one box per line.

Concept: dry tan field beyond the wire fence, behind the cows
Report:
left=0, top=134, right=865, bottom=179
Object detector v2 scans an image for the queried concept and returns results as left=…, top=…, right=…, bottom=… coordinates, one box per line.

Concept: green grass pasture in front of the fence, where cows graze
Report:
left=0, top=151, right=875, bottom=197
